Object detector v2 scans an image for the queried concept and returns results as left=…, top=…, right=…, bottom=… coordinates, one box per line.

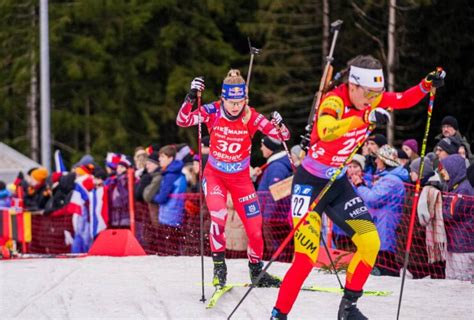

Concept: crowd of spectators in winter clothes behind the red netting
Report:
left=0, top=116, right=474, bottom=281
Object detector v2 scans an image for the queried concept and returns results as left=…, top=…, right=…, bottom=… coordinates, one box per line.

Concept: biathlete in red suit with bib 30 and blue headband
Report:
left=176, top=70, right=290, bottom=287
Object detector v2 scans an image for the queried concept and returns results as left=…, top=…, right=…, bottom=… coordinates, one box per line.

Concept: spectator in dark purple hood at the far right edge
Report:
left=440, top=154, right=474, bottom=281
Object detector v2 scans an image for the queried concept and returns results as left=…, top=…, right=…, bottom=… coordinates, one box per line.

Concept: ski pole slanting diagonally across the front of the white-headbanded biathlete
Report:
left=227, top=125, right=374, bottom=320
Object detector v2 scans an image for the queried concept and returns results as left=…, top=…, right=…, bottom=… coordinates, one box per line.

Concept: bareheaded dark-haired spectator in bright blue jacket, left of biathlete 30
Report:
left=153, top=145, right=187, bottom=227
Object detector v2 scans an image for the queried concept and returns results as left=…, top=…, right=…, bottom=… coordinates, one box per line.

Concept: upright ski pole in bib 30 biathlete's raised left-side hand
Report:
left=197, top=91, right=206, bottom=303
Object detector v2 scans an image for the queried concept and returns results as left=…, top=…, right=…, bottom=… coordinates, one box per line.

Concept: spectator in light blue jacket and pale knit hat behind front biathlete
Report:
left=353, top=144, right=409, bottom=276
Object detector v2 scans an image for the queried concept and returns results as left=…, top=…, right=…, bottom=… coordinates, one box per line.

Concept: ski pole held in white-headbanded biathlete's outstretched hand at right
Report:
left=397, top=88, right=436, bottom=320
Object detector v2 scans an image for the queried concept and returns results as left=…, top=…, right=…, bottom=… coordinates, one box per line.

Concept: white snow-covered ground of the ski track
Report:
left=0, top=256, right=474, bottom=320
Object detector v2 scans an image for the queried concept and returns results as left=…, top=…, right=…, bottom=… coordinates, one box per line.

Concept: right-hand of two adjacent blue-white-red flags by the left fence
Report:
left=89, top=186, right=109, bottom=239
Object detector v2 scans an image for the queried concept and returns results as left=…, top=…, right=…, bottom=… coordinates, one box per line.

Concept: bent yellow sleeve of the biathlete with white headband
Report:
left=317, top=96, right=364, bottom=141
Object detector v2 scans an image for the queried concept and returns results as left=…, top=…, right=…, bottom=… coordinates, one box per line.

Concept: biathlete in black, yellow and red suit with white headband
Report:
left=271, top=56, right=445, bottom=320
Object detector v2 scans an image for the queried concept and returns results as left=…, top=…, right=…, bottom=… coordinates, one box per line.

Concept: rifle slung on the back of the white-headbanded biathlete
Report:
left=300, top=20, right=343, bottom=159
